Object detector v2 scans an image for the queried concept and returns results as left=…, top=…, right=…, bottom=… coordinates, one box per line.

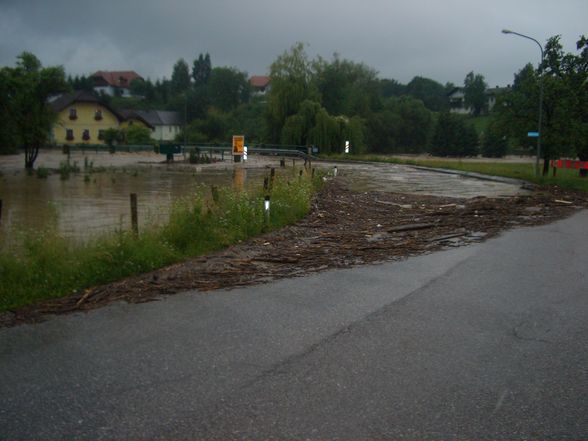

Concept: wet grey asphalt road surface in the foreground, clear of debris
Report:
left=0, top=211, right=588, bottom=441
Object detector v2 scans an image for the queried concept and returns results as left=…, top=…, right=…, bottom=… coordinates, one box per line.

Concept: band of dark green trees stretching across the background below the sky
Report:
left=0, top=36, right=588, bottom=170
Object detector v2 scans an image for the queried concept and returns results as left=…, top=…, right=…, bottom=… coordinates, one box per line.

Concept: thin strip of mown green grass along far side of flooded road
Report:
left=329, top=155, right=588, bottom=192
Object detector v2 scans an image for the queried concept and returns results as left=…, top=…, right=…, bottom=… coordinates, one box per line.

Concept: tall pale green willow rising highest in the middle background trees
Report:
left=267, top=43, right=319, bottom=142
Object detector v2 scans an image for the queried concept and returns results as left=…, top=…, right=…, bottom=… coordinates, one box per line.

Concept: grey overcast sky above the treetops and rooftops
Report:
left=0, top=0, right=588, bottom=87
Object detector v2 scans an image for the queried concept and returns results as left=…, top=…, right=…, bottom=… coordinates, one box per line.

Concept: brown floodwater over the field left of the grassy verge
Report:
left=0, top=152, right=279, bottom=241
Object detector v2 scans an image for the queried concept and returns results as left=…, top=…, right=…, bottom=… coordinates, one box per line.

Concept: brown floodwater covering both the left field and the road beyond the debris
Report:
left=0, top=151, right=522, bottom=244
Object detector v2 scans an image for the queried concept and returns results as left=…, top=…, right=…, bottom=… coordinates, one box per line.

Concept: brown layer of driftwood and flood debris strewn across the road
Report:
left=0, top=181, right=588, bottom=327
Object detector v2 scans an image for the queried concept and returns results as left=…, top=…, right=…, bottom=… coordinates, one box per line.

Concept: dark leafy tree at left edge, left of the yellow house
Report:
left=0, top=52, right=67, bottom=169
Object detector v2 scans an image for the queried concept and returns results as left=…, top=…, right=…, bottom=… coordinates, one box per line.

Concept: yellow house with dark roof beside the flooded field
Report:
left=51, top=91, right=124, bottom=144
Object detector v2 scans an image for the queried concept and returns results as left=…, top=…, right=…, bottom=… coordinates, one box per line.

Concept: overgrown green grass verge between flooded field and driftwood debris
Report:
left=0, top=170, right=322, bottom=311
